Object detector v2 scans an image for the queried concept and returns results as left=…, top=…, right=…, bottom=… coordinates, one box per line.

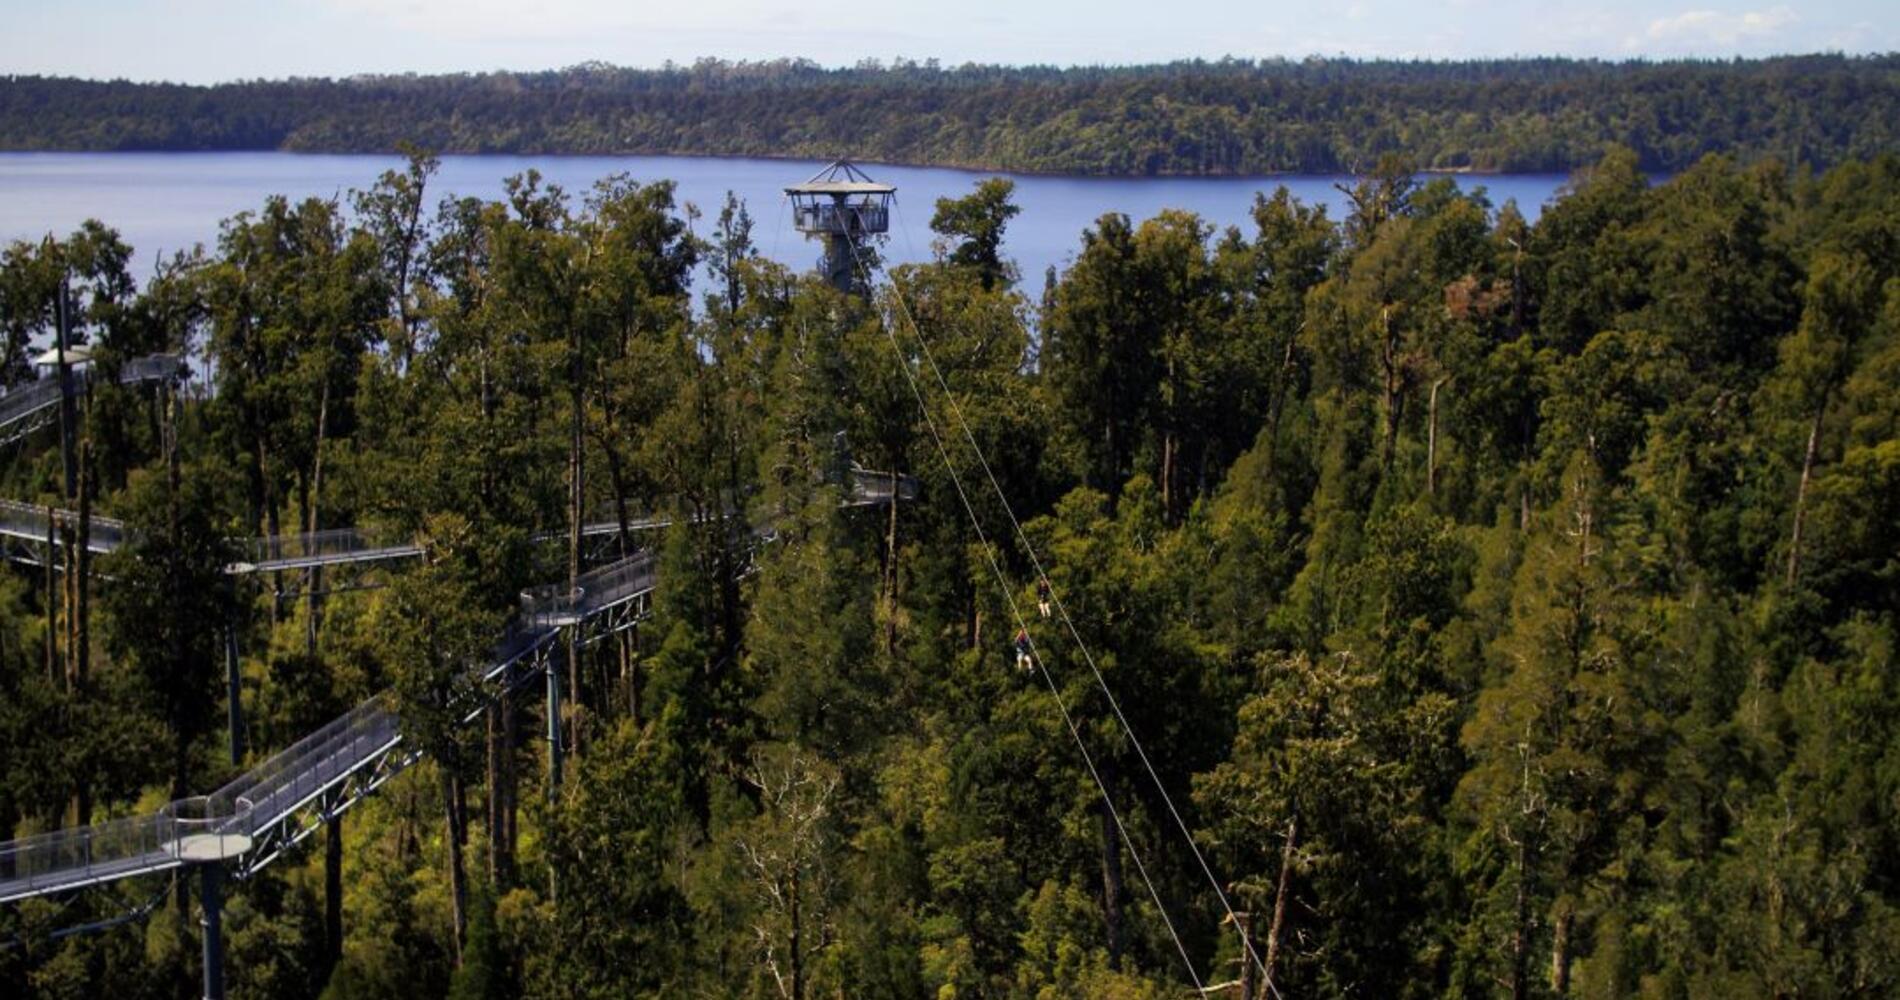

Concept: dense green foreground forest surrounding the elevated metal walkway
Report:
left=0, top=147, right=1900, bottom=1000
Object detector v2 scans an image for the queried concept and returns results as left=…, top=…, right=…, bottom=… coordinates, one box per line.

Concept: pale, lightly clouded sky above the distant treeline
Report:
left=0, top=0, right=1900, bottom=84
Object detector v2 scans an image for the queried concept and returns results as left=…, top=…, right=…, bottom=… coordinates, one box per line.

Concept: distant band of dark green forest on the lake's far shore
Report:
left=0, top=55, right=1900, bottom=175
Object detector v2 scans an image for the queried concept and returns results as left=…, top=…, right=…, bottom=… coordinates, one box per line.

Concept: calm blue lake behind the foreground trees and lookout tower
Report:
left=0, top=152, right=1566, bottom=291
